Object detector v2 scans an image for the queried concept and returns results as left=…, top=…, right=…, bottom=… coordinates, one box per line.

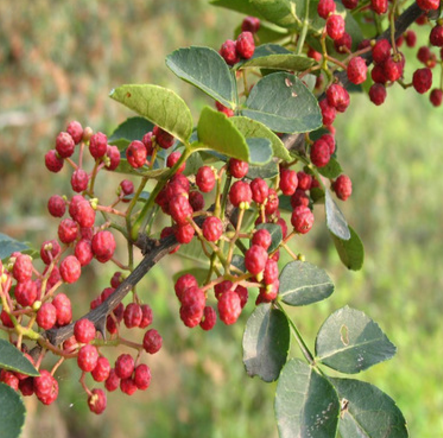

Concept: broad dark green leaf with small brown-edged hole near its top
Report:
left=242, top=72, right=322, bottom=134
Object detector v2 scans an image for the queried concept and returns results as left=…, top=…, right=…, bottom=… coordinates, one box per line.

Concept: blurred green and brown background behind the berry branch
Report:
left=0, top=0, right=443, bottom=438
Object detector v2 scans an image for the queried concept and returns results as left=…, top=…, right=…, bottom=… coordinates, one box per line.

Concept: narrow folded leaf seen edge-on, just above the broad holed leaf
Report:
left=236, top=44, right=315, bottom=71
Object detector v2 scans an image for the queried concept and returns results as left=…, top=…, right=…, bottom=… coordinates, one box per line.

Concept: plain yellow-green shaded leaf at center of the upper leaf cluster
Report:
left=197, top=107, right=250, bottom=162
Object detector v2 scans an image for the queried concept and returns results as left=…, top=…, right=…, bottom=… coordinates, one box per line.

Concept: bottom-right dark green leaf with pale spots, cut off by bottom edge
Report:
left=330, top=379, right=409, bottom=438
